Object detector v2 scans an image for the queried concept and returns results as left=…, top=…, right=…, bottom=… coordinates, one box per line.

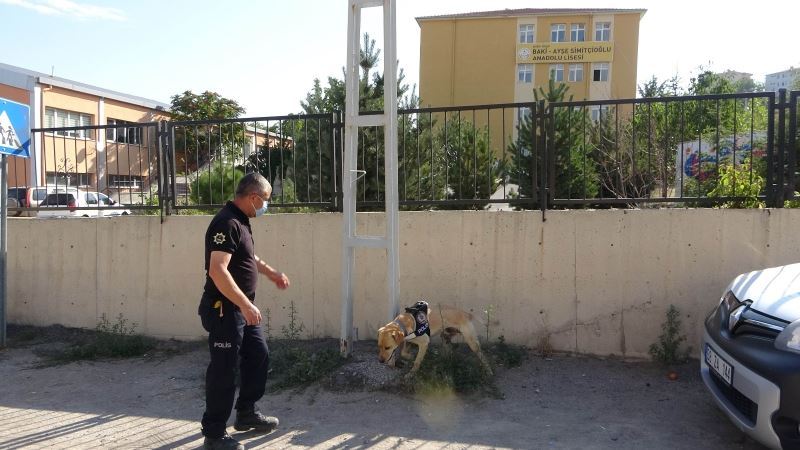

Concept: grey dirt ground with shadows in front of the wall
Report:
left=0, top=328, right=763, bottom=450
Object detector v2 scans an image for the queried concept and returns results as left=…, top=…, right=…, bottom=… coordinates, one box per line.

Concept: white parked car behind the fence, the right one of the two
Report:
left=37, top=188, right=131, bottom=217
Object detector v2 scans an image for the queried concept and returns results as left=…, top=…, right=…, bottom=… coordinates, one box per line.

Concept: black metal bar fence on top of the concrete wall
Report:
left=9, top=91, right=800, bottom=216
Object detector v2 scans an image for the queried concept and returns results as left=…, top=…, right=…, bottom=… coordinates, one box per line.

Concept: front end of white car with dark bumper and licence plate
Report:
left=700, top=264, right=800, bottom=449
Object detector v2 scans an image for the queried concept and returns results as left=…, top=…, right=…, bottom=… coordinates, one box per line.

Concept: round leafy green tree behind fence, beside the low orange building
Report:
left=170, top=91, right=245, bottom=172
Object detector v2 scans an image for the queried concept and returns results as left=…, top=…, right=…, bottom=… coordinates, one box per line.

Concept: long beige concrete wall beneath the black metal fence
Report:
left=8, top=209, right=800, bottom=356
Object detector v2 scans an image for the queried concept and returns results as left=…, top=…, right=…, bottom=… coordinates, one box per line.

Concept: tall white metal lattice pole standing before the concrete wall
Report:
left=339, top=0, right=400, bottom=356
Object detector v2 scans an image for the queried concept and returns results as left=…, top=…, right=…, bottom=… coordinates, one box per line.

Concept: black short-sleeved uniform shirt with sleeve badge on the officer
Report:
left=203, top=202, right=258, bottom=301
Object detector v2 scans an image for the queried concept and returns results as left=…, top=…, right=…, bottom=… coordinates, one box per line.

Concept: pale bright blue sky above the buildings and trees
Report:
left=0, top=0, right=800, bottom=117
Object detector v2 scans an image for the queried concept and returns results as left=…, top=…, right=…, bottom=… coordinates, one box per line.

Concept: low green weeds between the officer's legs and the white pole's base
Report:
left=268, top=339, right=345, bottom=392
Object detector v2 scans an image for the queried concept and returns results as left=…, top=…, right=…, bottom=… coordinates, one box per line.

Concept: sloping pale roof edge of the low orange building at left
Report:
left=0, top=63, right=170, bottom=111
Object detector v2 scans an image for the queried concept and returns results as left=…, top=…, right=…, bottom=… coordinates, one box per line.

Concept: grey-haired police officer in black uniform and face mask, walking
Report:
left=198, top=173, right=289, bottom=450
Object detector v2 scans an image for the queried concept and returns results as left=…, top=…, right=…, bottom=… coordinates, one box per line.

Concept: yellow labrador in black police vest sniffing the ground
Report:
left=378, top=302, right=492, bottom=377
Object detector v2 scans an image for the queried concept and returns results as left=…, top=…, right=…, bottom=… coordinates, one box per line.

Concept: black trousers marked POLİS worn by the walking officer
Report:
left=199, top=299, right=269, bottom=438
